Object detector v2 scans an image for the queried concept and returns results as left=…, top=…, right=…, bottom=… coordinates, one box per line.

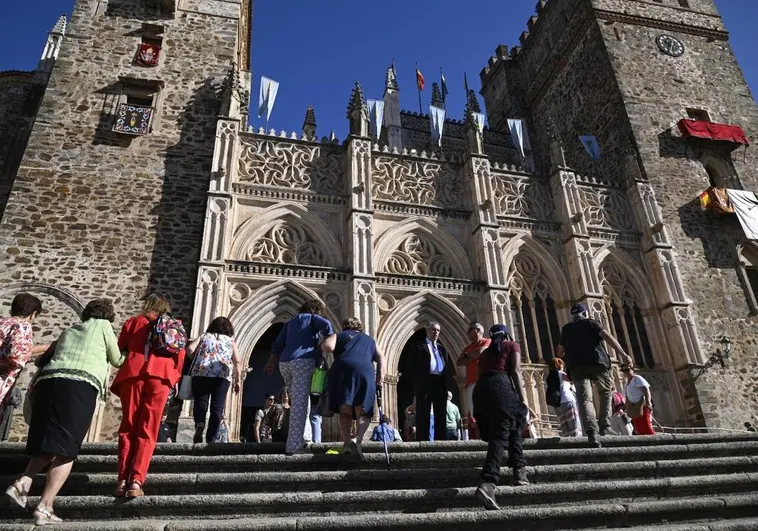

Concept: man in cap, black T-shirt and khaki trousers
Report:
left=556, top=304, right=632, bottom=448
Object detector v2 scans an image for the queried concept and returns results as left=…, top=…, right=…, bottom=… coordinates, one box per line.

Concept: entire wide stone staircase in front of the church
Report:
left=0, top=433, right=758, bottom=531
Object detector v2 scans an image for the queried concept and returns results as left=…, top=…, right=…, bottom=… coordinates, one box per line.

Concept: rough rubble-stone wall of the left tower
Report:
left=0, top=0, right=251, bottom=439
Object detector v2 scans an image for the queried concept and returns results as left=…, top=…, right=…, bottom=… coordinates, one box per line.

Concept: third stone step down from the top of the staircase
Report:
left=0, top=456, right=758, bottom=496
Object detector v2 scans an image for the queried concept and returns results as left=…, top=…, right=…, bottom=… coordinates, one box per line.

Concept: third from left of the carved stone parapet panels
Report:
left=492, top=174, right=553, bottom=220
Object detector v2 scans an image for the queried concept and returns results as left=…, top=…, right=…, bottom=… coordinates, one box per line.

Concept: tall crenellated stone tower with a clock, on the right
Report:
left=481, top=0, right=758, bottom=426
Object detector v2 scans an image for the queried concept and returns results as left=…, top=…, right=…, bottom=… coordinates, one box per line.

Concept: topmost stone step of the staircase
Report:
left=0, top=432, right=758, bottom=458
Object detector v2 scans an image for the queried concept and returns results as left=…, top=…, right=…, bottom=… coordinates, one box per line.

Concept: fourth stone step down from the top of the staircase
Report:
left=0, top=473, right=758, bottom=521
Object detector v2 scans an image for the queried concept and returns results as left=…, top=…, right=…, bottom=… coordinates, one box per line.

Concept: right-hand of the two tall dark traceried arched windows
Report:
left=600, top=260, right=655, bottom=369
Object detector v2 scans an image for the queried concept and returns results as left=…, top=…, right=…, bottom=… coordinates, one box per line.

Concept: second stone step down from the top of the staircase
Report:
left=0, top=440, right=758, bottom=475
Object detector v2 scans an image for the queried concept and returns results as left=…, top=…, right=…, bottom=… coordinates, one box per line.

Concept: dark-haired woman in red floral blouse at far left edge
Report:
left=0, top=293, right=47, bottom=423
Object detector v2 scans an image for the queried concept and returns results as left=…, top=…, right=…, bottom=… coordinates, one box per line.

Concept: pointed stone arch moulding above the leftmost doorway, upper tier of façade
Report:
left=230, top=203, right=344, bottom=268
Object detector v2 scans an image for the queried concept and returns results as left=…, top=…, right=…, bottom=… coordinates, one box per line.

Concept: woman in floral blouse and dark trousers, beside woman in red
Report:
left=187, top=317, right=242, bottom=444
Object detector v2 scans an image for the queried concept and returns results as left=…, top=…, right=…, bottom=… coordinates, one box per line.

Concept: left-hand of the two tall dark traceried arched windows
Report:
left=510, top=253, right=561, bottom=363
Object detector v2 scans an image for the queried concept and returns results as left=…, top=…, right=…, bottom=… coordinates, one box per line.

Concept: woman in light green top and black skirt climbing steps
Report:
left=6, top=299, right=124, bottom=525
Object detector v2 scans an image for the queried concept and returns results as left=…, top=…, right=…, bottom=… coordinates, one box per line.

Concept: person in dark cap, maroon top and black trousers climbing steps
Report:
left=474, top=324, right=529, bottom=510
